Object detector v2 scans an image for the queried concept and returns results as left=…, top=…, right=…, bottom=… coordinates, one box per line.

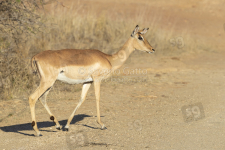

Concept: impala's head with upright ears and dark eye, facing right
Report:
left=131, top=25, right=155, bottom=53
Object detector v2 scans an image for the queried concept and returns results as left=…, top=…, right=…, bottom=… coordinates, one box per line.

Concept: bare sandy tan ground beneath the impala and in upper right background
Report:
left=0, top=0, right=225, bottom=150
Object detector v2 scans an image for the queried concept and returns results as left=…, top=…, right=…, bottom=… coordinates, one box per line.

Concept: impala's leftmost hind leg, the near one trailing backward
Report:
left=29, top=81, right=54, bottom=136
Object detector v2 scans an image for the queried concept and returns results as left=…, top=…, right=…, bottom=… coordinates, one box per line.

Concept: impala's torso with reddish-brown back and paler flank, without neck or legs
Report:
left=32, top=49, right=111, bottom=84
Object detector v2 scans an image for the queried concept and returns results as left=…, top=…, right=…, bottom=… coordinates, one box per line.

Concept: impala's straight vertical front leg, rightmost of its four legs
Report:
left=94, top=79, right=107, bottom=130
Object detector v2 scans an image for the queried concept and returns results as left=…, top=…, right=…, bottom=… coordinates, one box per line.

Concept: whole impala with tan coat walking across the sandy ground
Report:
left=29, top=25, right=155, bottom=136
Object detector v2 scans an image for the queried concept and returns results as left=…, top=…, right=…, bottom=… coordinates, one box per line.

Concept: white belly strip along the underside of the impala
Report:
left=57, top=73, right=93, bottom=84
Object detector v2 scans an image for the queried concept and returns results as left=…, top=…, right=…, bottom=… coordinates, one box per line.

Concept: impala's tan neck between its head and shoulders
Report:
left=109, top=37, right=135, bottom=70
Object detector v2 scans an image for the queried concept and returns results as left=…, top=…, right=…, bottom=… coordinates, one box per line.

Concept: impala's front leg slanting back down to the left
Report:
left=65, top=83, right=91, bottom=131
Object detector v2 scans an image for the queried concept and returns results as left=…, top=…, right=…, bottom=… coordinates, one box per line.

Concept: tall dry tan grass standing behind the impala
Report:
left=0, top=2, right=207, bottom=99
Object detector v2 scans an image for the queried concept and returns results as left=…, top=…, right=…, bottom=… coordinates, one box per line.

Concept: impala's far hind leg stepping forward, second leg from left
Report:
left=39, top=89, right=60, bottom=130
